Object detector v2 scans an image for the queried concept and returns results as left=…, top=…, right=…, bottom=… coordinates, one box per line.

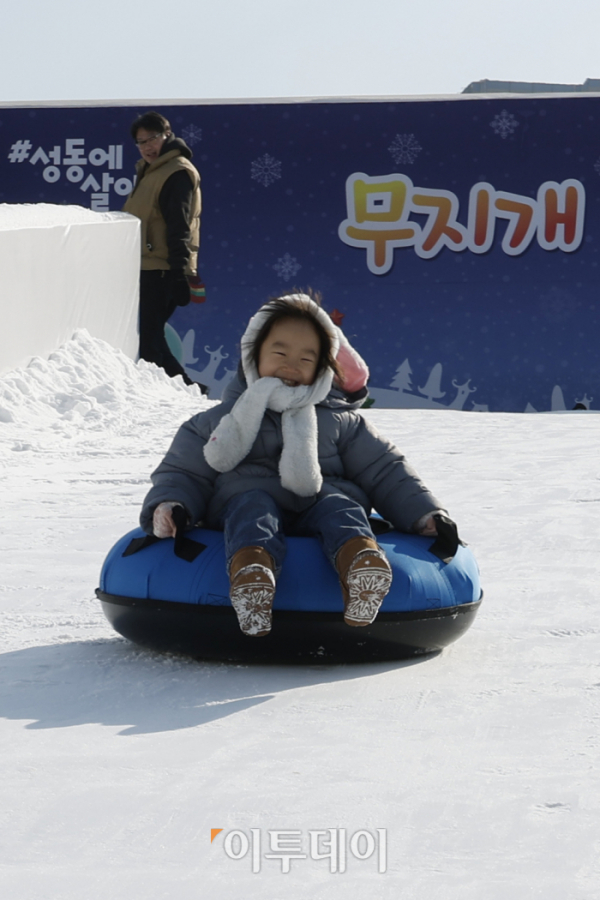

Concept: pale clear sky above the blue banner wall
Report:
left=0, top=0, right=600, bottom=103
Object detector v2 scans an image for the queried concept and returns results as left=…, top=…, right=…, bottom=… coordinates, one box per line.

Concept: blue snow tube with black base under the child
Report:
left=96, top=528, right=482, bottom=662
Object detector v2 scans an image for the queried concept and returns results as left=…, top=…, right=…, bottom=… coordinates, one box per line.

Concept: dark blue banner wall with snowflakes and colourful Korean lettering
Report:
left=0, top=93, right=600, bottom=412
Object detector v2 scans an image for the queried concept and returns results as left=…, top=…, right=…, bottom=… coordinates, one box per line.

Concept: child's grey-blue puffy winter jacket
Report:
left=140, top=375, right=442, bottom=534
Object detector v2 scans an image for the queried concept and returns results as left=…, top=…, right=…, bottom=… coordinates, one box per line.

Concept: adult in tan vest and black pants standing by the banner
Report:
left=123, top=112, right=201, bottom=384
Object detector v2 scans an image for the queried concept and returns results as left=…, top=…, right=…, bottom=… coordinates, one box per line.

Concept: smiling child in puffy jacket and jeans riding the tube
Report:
left=140, top=294, right=448, bottom=637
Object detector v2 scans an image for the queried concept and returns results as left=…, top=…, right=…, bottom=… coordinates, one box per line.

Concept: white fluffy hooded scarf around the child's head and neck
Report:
left=204, top=294, right=339, bottom=497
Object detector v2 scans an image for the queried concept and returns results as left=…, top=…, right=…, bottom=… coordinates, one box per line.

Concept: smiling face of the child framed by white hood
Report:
left=258, top=319, right=321, bottom=387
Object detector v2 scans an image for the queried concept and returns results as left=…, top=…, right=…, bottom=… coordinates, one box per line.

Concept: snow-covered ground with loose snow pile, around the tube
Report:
left=0, top=332, right=600, bottom=900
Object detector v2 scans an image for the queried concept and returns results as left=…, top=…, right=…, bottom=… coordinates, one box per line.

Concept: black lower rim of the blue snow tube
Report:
left=96, top=588, right=483, bottom=663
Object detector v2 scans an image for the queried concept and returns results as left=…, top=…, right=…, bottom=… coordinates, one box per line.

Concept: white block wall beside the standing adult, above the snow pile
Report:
left=0, top=203, right=140, bottom=374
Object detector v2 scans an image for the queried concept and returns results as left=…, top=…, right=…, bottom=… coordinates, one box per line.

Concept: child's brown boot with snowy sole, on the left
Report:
left=229, top=547, right=275, bottom=637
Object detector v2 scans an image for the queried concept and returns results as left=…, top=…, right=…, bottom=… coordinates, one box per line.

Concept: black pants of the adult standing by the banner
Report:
left=140, top=269, right=191, bottom=384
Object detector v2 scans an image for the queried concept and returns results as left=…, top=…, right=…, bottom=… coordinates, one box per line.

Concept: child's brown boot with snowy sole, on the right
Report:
left=335, top=537, right=392, bottom=625
